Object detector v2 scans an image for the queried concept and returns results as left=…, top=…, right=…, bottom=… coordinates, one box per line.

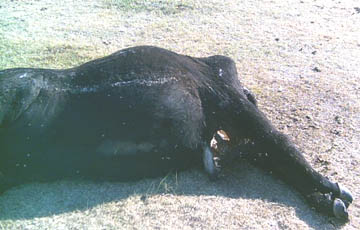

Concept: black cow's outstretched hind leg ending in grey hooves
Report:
left=226, top=96, right=352, bottom=219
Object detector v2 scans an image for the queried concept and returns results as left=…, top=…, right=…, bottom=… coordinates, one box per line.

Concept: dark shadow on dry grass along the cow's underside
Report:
left=0, top=161, right=344, bottom=228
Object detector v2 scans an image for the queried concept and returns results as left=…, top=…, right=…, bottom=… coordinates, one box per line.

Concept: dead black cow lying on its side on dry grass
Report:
left=0, top=46, right=352, bottom=219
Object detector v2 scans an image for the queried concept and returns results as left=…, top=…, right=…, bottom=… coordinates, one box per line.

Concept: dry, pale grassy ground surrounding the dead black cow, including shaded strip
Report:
left=0, top=0, right=360, bottom=229
